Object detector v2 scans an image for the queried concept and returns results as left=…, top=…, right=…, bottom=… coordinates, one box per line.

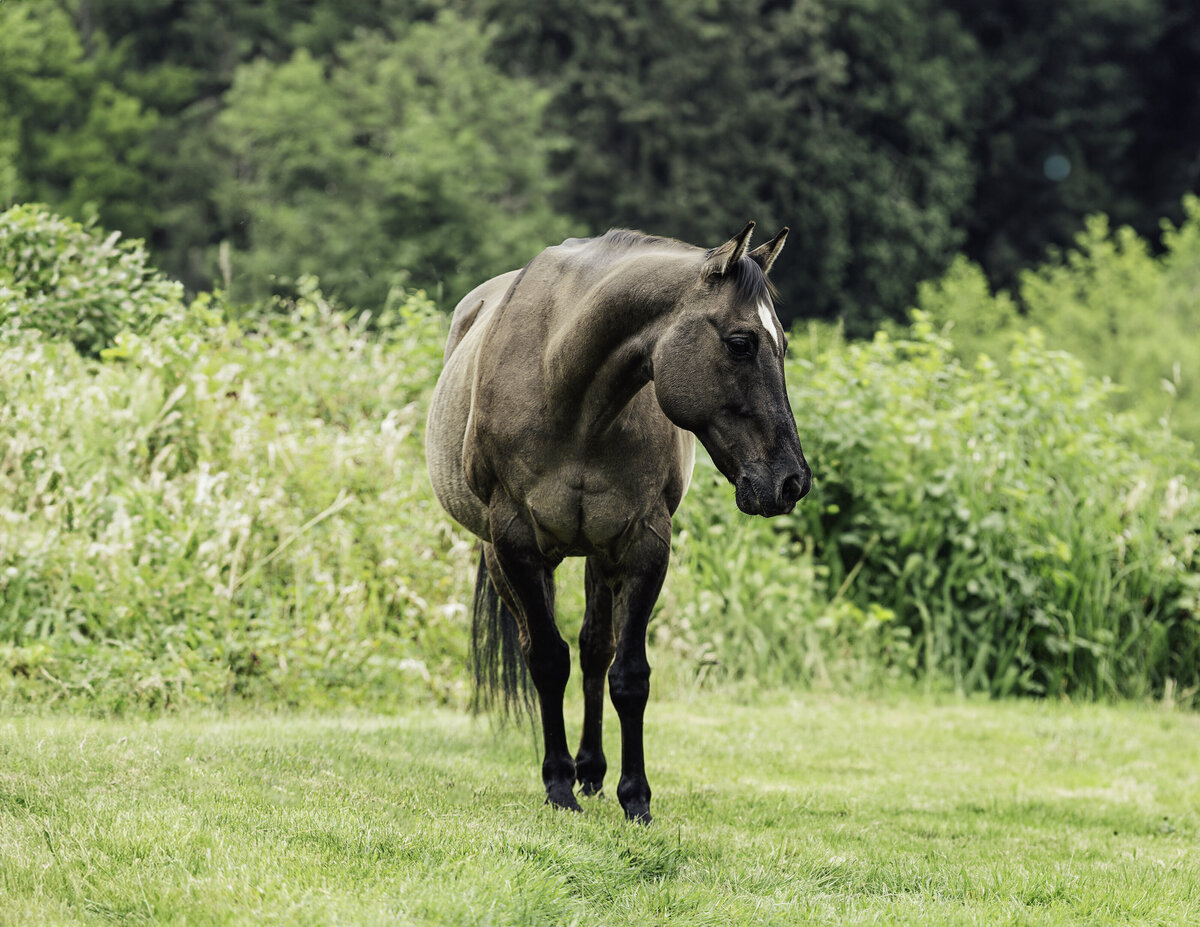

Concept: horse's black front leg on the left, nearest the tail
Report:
left=488, top=498, right=583, bottom=811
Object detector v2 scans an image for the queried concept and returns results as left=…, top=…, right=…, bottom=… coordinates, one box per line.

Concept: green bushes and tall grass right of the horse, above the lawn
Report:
left=652, top=312, right=1200, bottom=704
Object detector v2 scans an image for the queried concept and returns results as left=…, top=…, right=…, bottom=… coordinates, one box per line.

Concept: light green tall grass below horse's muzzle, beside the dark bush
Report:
left=650, top=451, right=916, bottom=692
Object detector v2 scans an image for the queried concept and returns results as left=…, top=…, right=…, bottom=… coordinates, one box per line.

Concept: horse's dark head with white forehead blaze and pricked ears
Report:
left=652, top=222, right=812, bottom=516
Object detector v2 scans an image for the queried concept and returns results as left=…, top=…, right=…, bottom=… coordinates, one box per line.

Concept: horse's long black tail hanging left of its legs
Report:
left=470, top=551, right=533, bottom=719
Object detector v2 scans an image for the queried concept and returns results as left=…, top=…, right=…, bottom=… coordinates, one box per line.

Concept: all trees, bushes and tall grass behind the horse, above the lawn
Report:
left=0, top=0, right=1200, bottom=710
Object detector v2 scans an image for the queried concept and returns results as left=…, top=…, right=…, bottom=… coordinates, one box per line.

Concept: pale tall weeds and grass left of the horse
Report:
left=0, top=271, right=472, bottom=707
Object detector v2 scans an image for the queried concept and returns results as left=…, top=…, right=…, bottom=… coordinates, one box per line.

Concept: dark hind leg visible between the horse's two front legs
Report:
left=575, top=557, right=617, bottom=795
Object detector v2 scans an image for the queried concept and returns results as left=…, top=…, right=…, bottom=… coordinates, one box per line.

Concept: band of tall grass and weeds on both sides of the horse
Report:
left=0, top=204, right=1200, bottom=710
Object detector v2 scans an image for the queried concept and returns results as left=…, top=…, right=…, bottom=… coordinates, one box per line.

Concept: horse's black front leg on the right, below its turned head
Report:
left=608, top=516, right=671, bottom=824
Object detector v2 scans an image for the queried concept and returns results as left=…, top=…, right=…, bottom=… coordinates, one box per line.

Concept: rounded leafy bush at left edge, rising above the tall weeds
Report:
left=0, top=205, right=184, bottom=355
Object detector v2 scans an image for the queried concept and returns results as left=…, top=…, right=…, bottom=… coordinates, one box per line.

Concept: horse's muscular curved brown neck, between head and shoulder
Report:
left=544, top=252, right=696, bottom=431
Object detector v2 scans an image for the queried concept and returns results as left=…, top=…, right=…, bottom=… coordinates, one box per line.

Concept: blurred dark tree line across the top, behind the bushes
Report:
left=0, top=0, right=1200, bottom=330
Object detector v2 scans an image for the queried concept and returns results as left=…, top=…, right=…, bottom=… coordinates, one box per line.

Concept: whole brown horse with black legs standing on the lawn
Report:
left=426, top=222, right=812, bottom=824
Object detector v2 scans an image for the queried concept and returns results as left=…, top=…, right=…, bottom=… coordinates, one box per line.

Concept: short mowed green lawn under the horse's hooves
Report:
left=0, top=695, right=1200, bottom=926
